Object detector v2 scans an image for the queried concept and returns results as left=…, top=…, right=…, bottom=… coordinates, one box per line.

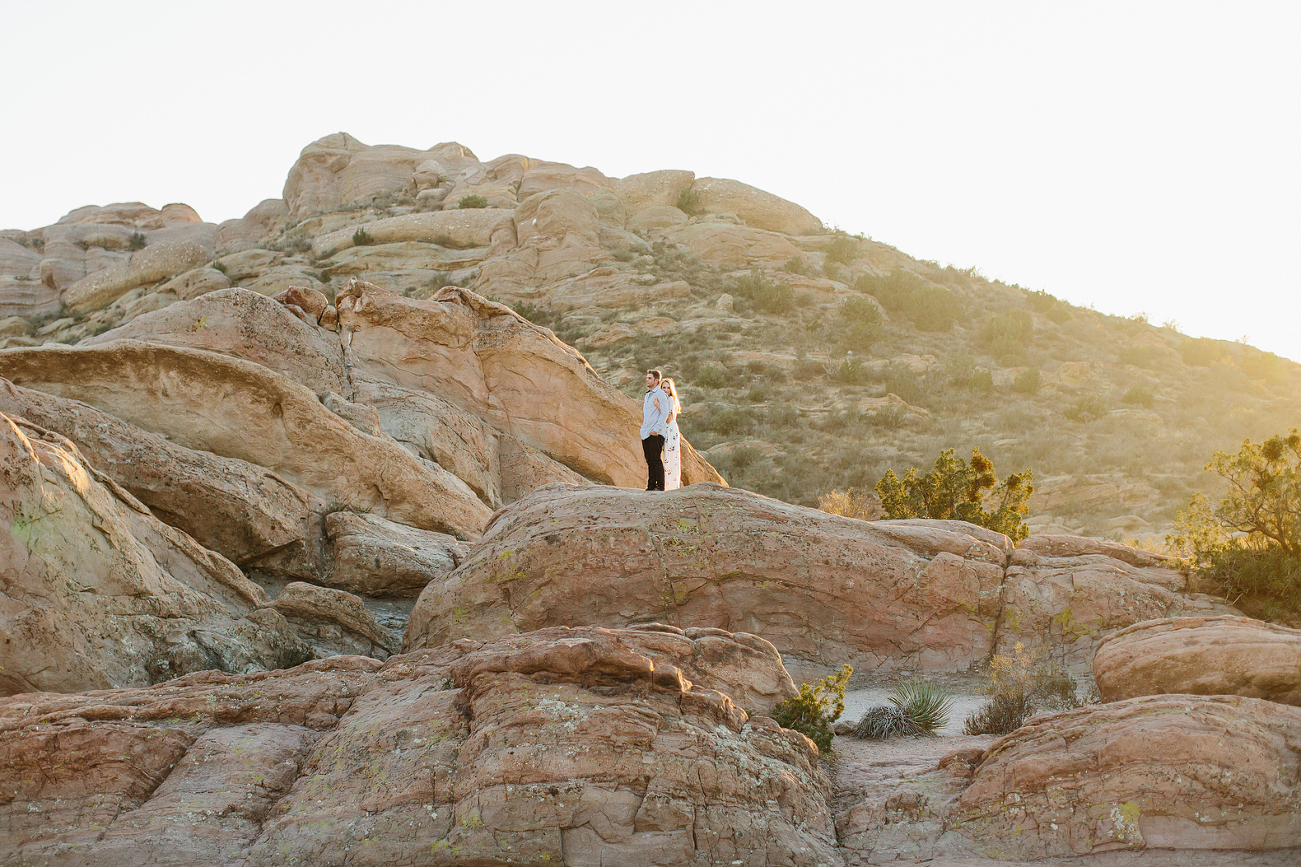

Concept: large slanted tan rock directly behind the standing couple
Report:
left=336, top=279, right=721, bottom=488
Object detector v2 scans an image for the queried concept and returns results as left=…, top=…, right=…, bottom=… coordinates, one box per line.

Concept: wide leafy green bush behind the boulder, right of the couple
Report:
left=877, top=448, right=1034, bottom=542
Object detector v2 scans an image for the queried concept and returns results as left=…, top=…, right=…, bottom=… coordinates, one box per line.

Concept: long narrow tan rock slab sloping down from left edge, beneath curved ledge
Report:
left=0, top=379, right=330, bottom=581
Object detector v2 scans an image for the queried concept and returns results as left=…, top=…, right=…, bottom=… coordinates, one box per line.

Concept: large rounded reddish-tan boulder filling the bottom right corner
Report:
left=948, top=695, right=1301, bottom=863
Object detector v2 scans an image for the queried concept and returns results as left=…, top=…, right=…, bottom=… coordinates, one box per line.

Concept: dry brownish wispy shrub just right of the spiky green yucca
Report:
left=963, top=642, right=1082, bottom=734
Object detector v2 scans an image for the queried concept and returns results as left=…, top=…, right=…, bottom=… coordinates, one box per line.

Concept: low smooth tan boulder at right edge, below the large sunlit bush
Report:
left=1093, top=616, right=1301, bottom=707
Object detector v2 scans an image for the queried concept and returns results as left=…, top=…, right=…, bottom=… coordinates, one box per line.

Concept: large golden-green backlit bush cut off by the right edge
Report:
left=1167, top=428, right=1301, bottom=622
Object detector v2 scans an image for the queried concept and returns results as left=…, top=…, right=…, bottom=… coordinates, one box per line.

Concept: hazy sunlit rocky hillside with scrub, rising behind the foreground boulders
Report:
left=0, top=133, right=1301, bottom=539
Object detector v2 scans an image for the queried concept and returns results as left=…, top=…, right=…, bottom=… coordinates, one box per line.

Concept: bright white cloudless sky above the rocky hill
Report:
left=0, top=0, right=1301, bottom=361
